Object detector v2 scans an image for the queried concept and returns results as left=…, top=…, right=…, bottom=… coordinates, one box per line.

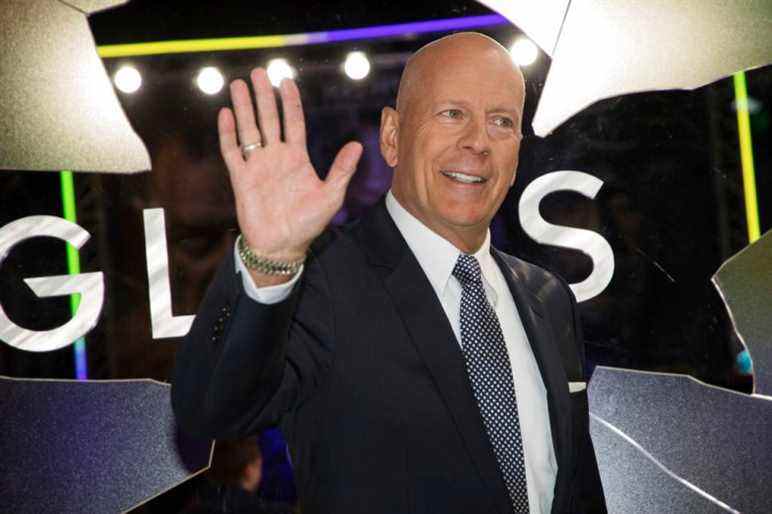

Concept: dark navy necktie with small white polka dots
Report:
left=453, top=254, right=528, bottom=513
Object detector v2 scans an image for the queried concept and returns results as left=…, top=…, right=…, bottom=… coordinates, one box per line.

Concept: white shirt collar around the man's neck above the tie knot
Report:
left=386, top=190, right=495, bottom=298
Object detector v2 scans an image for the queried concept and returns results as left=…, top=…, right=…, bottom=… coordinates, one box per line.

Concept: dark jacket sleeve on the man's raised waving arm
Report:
left=171, top=243, right=333, bottom=439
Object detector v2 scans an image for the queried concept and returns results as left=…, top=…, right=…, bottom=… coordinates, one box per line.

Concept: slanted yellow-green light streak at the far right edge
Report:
left=733, top=71, right=761, bottom=243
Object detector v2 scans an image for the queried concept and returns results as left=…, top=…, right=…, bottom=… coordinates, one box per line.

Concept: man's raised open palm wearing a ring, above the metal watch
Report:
left=217, top=68, right=362, bottom=286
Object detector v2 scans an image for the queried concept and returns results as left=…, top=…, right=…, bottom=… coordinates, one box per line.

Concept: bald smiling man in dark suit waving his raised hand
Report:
left=172, top=33, right=605, bottom=514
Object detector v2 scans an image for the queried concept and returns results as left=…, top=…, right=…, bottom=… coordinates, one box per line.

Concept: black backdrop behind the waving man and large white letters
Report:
left=0, top=0, right=772, bottom=512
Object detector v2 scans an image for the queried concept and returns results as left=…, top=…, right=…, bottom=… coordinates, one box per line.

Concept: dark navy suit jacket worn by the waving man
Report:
left=172, top=201, right=605, bottom=514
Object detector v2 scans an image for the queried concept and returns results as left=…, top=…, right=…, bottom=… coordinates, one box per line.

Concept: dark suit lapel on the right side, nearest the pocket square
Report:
left=492, top=249, right=573, bottom=512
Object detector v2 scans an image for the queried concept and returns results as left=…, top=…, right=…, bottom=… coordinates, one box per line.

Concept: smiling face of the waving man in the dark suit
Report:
left=382, top=42, right=524, bottom=246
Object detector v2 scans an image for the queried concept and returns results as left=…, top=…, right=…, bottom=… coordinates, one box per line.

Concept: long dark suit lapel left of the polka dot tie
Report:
left=359, top=202, right=512, bottom=514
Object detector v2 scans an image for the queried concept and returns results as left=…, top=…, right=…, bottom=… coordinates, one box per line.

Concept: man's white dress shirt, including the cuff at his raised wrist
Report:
left=234, top=191, right=557, bottom=514
